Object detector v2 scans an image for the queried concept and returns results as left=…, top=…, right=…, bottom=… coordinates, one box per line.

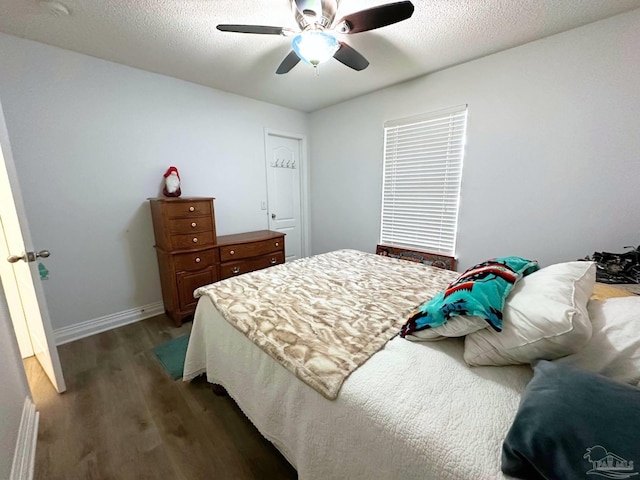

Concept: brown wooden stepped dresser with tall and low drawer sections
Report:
left=149, top=197, right=284, bottom=326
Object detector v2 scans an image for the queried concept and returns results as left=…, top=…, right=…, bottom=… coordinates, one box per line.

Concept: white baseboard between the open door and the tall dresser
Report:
left=53, top=302, right=164, bottom=345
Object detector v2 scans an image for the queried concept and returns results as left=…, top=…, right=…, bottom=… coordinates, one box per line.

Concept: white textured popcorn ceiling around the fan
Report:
left=0, top=0, right=640, bottom=112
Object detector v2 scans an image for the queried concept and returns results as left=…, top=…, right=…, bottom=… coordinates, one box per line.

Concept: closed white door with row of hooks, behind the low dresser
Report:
left=266, top=131, right=306, bottom=262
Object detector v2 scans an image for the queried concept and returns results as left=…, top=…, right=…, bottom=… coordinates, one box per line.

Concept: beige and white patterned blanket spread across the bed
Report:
left=194, top=250, right=458, bottom=399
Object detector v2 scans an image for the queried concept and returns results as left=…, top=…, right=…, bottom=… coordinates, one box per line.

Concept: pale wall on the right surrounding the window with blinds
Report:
left=310, top=10, right=640, bottom=268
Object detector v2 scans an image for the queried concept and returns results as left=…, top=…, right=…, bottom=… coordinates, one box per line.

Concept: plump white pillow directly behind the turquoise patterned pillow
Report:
left=464, top=261, right=596, bottom=365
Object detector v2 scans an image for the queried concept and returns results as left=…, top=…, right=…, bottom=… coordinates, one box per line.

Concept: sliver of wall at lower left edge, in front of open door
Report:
left=0, top=283, right=30, bottom=478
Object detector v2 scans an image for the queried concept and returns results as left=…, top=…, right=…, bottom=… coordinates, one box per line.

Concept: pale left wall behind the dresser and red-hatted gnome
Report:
left=0, top=34, right=308, bottom=330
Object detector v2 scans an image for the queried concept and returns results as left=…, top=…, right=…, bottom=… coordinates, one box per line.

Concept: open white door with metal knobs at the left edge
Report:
left=0, top=99, right=66, bottom=392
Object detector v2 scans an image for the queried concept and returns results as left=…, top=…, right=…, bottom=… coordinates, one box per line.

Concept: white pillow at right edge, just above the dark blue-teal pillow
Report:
left=556, top=297, right=640, bottom=386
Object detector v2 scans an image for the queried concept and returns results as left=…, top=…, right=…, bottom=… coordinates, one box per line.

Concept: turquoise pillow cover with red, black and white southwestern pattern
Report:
left=400, top=257, right=539, bottom=337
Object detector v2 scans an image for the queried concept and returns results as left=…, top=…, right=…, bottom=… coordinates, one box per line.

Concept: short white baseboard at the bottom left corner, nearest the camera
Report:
left=9, top=397, right=40, bottom=480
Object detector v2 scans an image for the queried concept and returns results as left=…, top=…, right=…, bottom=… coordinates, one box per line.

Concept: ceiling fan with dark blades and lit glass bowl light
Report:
left=217, top=0, right=414, bottom=74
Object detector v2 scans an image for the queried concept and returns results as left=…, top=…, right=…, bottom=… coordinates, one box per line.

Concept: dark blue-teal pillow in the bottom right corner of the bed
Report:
left=502, top=360, right=640, bottom=480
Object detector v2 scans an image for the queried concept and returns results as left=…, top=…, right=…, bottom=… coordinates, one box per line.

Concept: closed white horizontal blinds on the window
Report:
left=380, top=105, right=467, bottom=256
